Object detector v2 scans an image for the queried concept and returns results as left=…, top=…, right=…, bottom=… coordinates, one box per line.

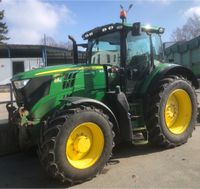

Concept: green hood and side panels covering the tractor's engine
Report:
left=12, top=65, right=106, bottom=125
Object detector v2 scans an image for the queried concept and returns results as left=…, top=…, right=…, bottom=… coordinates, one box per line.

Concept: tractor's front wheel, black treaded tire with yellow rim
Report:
left=39, top=107, right=114, bottom=184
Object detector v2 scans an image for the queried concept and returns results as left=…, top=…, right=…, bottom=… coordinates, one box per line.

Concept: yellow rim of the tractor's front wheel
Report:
left=66, top=122, right=104, bottom=169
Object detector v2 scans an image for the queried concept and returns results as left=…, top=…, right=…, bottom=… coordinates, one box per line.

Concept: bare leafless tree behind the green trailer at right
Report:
left=171, top=14, right=200, bottom=41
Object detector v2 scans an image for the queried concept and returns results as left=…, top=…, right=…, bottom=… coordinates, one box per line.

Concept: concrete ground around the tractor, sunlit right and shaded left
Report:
left=0, top=127, right=200, bottom=188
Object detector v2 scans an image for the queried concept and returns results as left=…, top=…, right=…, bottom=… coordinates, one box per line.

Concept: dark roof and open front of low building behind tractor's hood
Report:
left=0, top=44, right=86, bottom=66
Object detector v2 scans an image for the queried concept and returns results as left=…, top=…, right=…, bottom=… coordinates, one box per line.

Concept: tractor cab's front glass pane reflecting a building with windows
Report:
left=88, top=32, right=120, bottom=66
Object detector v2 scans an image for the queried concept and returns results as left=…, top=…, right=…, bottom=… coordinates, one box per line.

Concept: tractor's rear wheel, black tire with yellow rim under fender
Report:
left=145, top=76, right=197, bottom=148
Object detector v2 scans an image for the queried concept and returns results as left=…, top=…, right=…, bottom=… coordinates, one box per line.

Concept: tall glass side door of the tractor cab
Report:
left=125, top=31, right=151, bottom=96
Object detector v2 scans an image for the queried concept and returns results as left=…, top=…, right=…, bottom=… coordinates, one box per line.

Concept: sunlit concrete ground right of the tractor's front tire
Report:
left=74, top=127, right=200, bottom=188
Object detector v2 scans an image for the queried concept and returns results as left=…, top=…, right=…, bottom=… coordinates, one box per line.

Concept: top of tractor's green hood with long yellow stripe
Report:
left=11, top=64, right=102, bottom=81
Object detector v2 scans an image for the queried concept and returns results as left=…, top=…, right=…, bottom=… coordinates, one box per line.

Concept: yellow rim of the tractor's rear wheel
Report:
left=165, top=89, right=192, bottom=135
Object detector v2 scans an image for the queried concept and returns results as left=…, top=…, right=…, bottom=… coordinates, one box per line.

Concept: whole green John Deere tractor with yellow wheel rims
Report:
left=7, top=22, right=198, bottom=183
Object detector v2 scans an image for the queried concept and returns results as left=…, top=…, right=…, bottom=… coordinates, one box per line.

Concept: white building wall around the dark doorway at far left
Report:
left=0, top=57, right=44, bottom=85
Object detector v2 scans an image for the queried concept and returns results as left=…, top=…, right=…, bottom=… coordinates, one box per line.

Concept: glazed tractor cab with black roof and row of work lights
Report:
left=82, top=22, right=164, bottom=95
